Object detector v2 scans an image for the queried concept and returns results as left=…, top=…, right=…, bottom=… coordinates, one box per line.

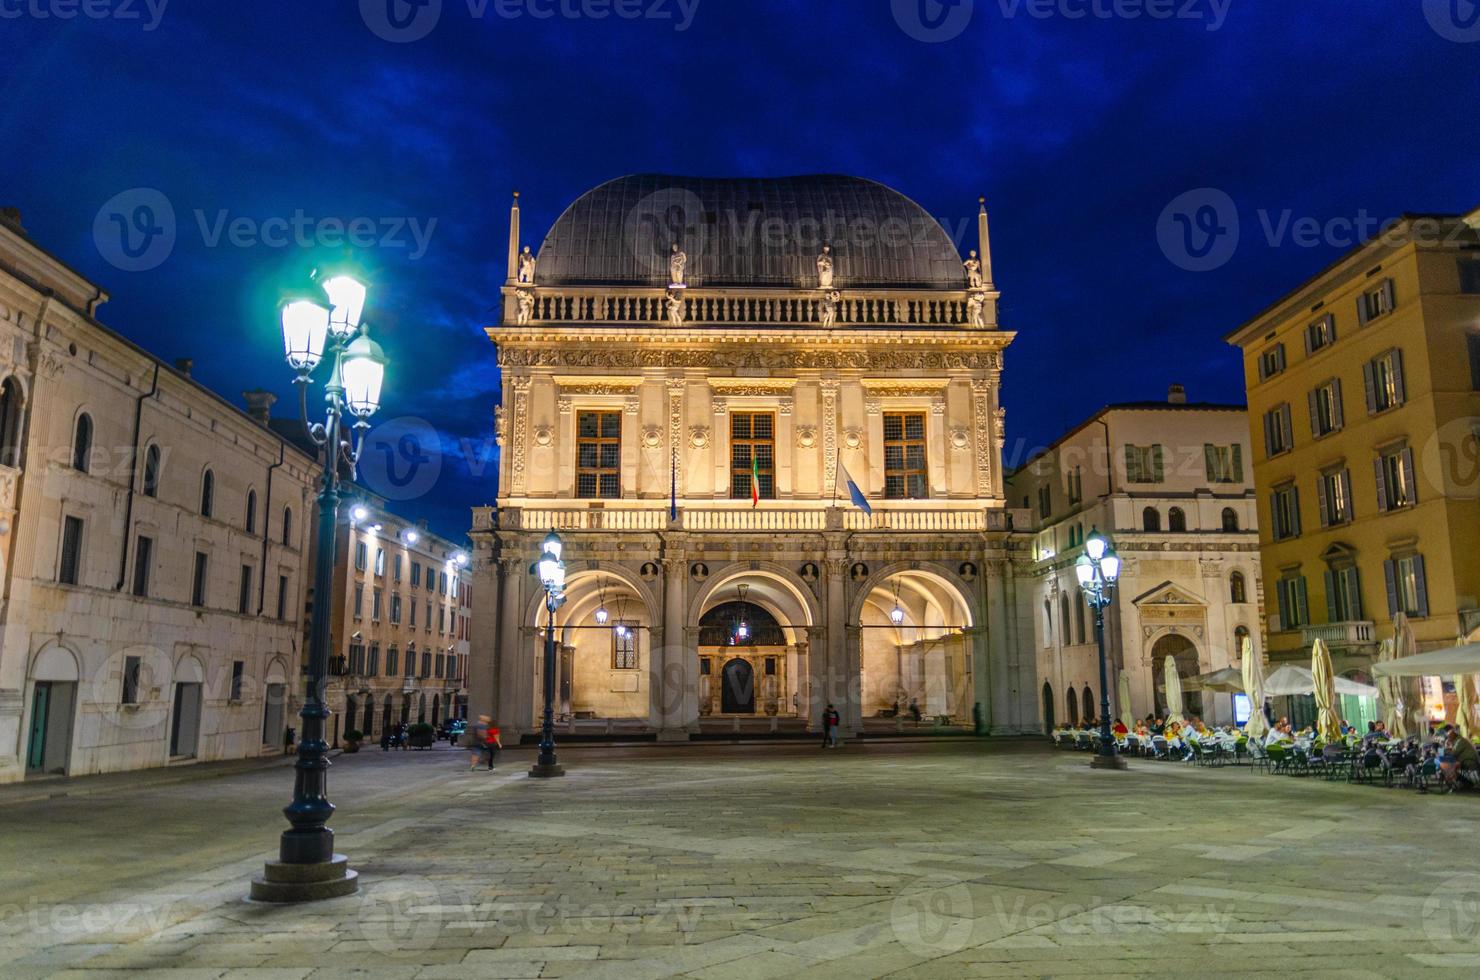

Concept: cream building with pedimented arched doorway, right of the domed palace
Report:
left=1008, top=386, right=1262, bottom=728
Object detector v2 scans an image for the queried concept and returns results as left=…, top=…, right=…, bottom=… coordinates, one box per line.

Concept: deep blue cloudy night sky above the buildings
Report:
left=0, top=0, right=1480, bottom=537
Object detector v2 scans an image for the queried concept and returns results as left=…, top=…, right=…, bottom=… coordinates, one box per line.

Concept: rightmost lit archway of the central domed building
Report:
left=858, top=568, right=975, bottom=721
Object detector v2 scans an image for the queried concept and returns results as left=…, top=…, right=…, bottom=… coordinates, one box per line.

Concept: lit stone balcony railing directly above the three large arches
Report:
left=491, top=503, right=1029, bottom=533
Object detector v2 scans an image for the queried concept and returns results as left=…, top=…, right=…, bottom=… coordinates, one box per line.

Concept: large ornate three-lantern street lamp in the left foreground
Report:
left=252, top=275, right=386, bottom=902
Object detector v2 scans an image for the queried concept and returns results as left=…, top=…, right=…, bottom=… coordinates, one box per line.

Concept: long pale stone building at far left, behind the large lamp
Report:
left=0, top=213, right=318, bottom=782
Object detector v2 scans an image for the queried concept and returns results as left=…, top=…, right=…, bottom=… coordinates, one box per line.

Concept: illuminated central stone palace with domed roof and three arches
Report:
left=471, top=176, right=1037, bottom=739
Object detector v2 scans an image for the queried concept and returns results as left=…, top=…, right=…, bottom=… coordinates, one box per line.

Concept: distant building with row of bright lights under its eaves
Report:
left=329, top=491, right=472, bottom=743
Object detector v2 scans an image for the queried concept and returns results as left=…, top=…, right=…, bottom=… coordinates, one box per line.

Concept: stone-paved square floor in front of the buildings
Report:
left=0, top=740, right=1480, bottom=980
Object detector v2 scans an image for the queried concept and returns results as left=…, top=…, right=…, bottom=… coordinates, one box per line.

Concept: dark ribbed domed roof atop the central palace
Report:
left=536, top=173, right=965, bottom=289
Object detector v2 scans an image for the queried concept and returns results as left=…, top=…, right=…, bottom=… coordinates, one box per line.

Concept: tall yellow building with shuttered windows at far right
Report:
left=1227, top=212, right=1480, bottom=683
